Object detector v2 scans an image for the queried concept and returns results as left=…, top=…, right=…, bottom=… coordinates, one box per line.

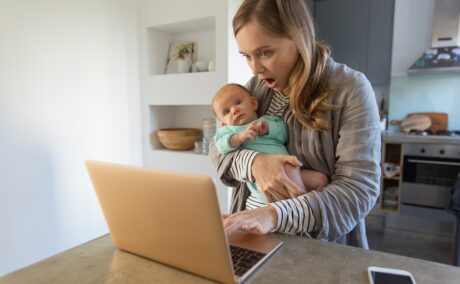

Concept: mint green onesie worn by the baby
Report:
left=214, top=115, right=289, bottom=204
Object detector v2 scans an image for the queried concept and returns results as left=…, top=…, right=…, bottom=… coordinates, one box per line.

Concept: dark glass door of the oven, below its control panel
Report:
left=401, top=156, right=460, bottom=208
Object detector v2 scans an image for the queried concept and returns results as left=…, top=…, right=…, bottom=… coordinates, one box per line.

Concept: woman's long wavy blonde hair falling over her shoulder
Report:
left=233, top=0, right=334, bottom=131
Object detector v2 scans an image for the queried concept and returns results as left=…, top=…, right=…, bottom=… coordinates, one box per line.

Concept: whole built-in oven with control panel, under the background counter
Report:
left=401, top=144, right=460, bottom=209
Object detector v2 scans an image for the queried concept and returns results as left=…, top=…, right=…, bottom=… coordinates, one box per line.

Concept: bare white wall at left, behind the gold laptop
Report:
left=0, top=0, right=141, bottom=275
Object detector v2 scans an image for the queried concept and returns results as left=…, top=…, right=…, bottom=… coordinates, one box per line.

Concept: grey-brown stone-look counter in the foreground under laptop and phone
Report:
left=0, top=234, right=460, bottom=283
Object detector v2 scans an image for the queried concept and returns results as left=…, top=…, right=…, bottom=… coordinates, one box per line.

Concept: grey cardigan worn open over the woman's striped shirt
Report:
left=210, top=59, right=381, bottom=248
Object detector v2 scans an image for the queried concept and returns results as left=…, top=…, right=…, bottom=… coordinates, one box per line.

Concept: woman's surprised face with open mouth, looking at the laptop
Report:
left=236, top=22, right=299, bottom=92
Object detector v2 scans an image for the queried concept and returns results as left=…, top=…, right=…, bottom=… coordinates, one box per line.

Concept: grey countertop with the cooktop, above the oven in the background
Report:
left=382, top=131, right=460, bottom=145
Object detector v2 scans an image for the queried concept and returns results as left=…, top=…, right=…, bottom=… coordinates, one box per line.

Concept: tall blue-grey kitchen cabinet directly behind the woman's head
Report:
left=307, top=0, right=394, bottom=86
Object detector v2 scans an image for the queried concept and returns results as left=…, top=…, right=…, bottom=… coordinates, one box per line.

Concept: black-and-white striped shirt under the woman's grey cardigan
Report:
left=231, top=91, right=316, bottom=235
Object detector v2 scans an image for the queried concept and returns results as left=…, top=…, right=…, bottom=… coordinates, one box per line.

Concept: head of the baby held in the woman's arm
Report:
left=212, top=84, right=258, bottom=126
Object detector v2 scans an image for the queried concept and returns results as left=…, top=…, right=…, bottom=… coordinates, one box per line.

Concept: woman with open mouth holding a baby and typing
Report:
left=210, top=0, right=380, bottom=248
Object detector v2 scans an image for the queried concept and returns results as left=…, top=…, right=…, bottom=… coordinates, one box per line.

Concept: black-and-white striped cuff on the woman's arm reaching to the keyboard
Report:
left=270, top=196, right=319, bottom=234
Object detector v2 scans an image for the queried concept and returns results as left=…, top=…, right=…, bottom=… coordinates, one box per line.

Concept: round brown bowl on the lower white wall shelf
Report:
left=157, top=128, right=202, bottom=151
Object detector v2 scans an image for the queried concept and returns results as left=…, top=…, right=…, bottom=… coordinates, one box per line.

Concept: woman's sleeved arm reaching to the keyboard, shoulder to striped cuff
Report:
left=273, top=75, right=381, bottom=241
